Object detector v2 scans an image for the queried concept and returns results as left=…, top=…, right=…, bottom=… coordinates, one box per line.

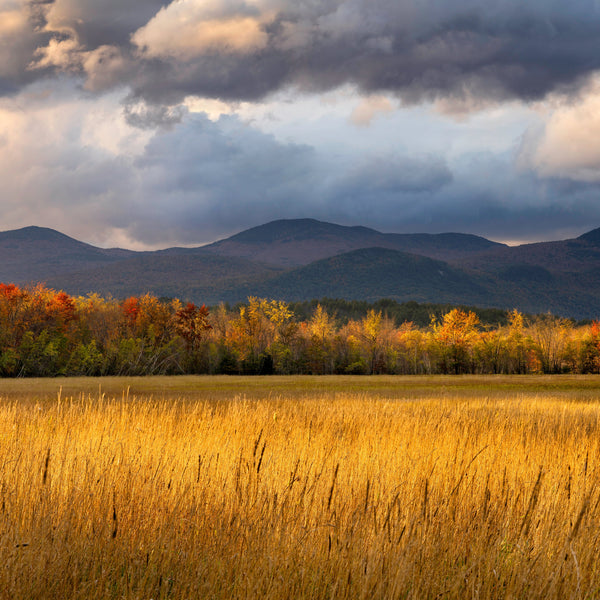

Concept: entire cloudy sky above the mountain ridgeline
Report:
left=0, top=0, right=600, bottom=249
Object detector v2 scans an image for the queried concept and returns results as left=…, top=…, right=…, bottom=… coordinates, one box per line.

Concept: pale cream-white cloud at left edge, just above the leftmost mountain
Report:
left=0, top=84, right=150, bottom=242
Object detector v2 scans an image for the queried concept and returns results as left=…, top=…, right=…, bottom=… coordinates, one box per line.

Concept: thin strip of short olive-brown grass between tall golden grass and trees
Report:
left=0, top=373, right=600, bottom=402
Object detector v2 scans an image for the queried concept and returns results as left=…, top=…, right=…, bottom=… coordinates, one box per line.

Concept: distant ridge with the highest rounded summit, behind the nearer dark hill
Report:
left=204, top=219, right=504, bottom=268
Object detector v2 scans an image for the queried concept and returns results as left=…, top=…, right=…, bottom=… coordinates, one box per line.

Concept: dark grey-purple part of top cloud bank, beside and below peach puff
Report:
left=124, top=0, right=600, bottom=102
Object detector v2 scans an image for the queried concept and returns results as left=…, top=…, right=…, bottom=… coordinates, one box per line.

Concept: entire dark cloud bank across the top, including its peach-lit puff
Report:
left=0, top=0, right=600, bottom=104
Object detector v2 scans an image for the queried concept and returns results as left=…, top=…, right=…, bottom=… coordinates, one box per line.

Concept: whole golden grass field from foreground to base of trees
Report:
left=0, top=376, right=600, bottom=600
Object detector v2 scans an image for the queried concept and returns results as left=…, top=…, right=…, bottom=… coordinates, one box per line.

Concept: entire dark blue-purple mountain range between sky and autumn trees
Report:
left=0, top=219, right=600, bottom=318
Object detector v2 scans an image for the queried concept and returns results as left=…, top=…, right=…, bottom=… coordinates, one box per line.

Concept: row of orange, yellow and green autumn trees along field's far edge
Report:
left=0, top=284, right=600, bottom=377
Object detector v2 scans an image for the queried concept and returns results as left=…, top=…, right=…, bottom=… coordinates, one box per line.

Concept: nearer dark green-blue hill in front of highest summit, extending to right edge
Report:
left=240, top=248, right=600, bottom=318
